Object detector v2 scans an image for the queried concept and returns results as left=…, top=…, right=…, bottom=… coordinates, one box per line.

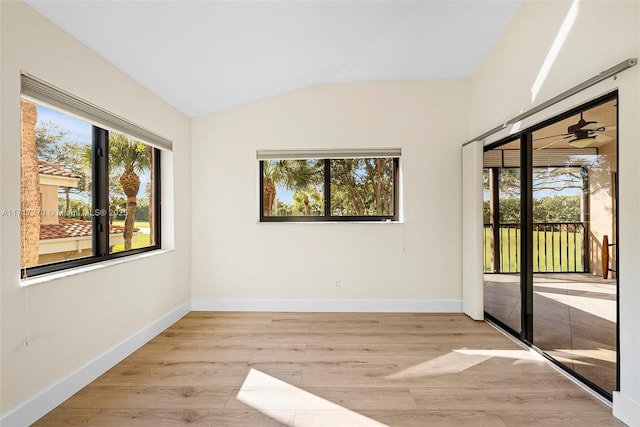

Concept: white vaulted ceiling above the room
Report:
left=27, top=0, right=523, bottom=117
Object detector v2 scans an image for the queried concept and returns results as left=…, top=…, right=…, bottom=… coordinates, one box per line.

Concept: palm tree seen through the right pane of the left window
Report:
left=109, top=133, right=150, bottom=250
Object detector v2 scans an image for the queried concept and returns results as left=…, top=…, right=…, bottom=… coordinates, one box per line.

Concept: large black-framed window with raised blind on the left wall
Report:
left=19, top=75, right=170, bottom=278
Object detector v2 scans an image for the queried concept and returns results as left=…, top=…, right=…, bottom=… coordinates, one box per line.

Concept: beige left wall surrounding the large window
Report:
left=0, top=1, right=191, bottom=413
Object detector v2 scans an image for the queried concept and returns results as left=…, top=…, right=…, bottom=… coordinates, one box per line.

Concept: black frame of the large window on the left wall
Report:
left=20, top=86, right=165, bottom=280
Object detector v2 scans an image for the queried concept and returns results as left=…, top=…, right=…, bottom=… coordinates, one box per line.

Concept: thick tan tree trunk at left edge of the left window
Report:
left=20, top=100, right=41, bottom=267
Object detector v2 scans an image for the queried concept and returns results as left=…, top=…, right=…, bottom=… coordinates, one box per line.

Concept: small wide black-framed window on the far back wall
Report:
left=258, top=149, right=400, bottom=222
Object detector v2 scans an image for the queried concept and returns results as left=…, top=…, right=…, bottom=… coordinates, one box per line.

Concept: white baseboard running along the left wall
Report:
left=0, top=302, right=191, bottom=427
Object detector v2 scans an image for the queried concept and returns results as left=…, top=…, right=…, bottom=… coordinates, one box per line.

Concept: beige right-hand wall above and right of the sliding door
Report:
left=470, top=0, right=640, bottom=425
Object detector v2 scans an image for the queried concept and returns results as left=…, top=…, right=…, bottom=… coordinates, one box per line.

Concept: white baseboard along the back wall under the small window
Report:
left=191, top=298, right=462, bottom=313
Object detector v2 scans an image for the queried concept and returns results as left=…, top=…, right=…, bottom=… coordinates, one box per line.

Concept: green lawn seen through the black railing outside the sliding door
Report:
left=484, top=228, right=583, bottom=272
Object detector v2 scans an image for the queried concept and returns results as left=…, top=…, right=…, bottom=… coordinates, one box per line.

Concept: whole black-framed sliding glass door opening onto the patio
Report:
left=484, top=94, right=619, bottom=398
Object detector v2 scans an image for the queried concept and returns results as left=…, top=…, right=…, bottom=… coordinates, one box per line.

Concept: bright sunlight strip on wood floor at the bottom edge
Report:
left=236, top=369, right=385, bottom=426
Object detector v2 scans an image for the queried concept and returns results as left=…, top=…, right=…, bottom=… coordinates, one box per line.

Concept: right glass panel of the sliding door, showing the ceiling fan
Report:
left=530, top=99, right=617, bottom=394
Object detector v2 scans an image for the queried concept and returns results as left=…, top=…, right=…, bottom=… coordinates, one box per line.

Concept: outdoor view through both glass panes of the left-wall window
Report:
left=21, top=100, right=155, bottom=267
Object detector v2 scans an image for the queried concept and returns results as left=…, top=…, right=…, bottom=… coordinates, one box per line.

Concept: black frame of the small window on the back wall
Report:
left=258, top=155, right=400, bottom=223
